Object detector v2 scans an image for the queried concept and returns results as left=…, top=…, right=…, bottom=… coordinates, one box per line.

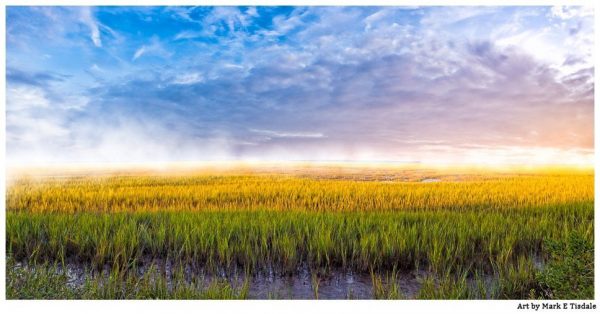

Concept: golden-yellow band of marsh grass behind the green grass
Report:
left=6, top=171, right=594, bottom=213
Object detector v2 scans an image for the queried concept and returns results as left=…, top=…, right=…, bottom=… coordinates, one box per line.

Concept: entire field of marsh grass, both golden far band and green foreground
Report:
left=6, top=172, right=594, bottom=299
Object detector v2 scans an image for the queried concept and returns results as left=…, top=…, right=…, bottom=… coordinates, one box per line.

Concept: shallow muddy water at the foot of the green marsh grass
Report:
left=15, top=259, right=542, bottom=299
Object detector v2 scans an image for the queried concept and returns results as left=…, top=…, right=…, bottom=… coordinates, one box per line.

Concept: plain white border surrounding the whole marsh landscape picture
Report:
left=0, top=0, right=600, bottom=314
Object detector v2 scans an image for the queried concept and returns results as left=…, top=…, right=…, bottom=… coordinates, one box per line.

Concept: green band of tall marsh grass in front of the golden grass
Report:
left=6, top=203, right=593, bottom=273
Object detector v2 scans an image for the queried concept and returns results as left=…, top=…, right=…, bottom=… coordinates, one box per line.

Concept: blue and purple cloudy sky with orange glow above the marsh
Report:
left=6, top=6, right=594, bottom=164
